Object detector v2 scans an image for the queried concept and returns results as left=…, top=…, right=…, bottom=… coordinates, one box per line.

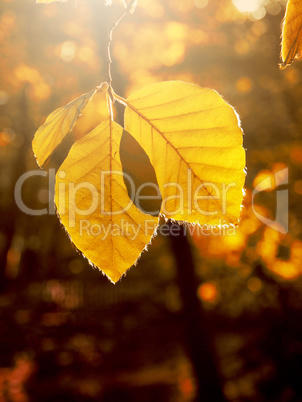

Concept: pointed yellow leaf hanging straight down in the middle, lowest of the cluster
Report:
left=55, top=119, right=158, bottom=282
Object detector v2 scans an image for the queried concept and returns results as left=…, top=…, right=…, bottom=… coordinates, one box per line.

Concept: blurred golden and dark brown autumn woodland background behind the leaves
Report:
left=0, top=0, right=302, bottom=402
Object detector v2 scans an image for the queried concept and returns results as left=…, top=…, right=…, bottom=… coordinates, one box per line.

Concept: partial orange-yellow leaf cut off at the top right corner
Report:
left=280, top=0, right=302, bottom=68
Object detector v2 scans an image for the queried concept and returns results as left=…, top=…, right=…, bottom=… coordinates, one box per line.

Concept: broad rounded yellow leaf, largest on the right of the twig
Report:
left=122, top=81, right=245, bottom=225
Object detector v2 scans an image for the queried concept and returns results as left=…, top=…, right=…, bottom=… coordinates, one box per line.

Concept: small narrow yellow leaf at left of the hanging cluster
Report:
left=32, top=90, right=95, bottom=167
